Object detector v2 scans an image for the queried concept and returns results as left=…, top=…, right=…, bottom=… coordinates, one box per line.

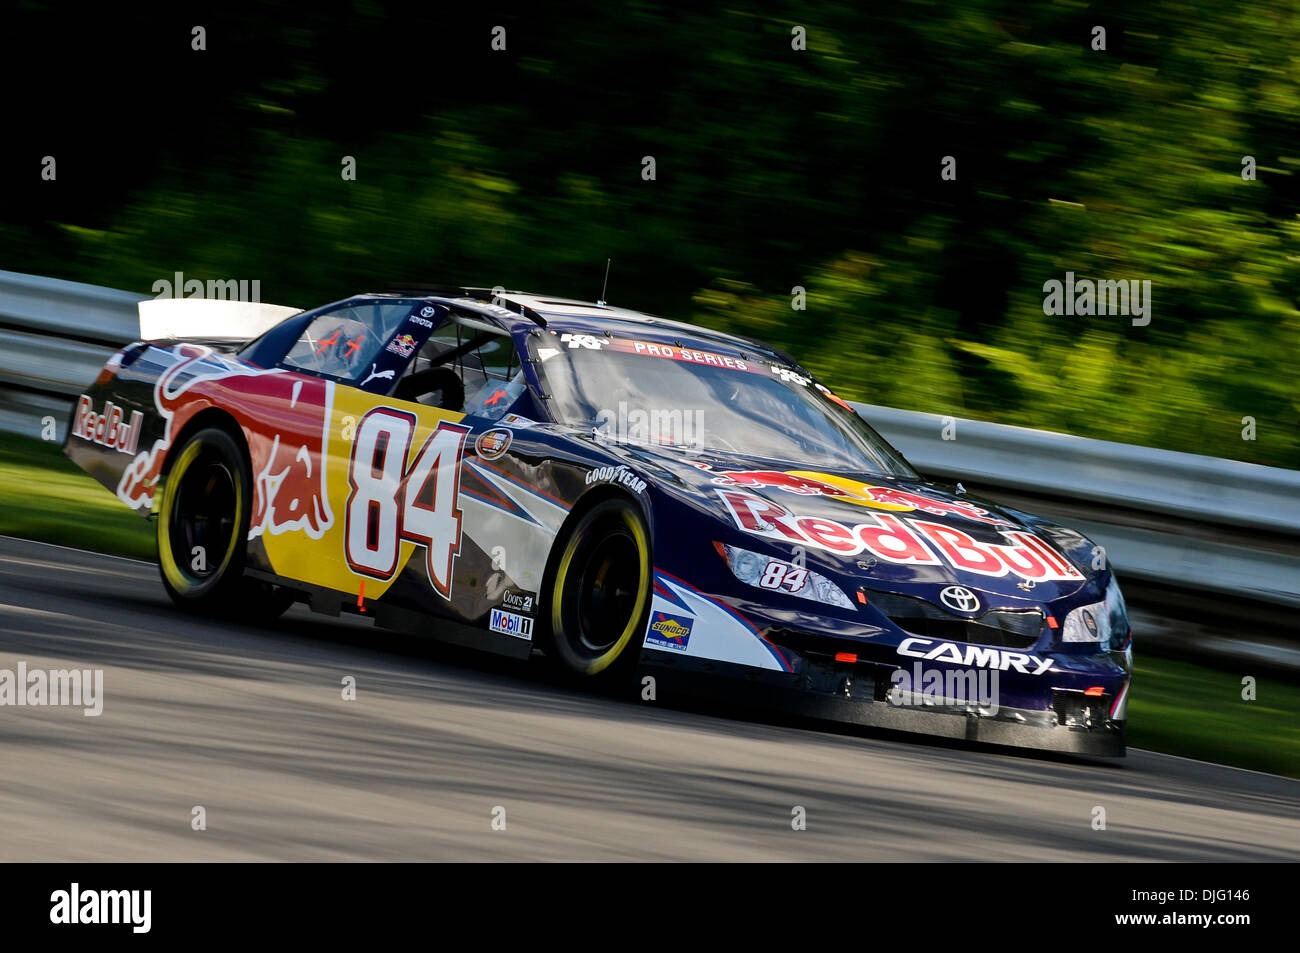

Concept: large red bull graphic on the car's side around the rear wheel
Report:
left=117, top=345, right=334, bottom=540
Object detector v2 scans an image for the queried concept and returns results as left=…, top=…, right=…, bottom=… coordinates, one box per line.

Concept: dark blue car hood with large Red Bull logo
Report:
left=606, top=436, right=1092, bottom=605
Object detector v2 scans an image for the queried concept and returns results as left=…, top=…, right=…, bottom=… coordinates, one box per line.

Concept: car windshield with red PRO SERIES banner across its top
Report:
left=532, top=334, right=917, bottom=478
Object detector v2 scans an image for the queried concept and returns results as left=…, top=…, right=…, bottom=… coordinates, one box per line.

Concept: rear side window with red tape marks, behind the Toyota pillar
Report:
left=282, top=300, right=416, bottom=381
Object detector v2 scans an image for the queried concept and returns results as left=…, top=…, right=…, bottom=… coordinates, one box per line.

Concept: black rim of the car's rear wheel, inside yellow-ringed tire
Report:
left=170, top=454, right=235, bottom=581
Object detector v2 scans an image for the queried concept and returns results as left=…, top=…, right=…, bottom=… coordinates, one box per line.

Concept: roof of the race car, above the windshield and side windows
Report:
left=361, top=285, right=800, bottom=367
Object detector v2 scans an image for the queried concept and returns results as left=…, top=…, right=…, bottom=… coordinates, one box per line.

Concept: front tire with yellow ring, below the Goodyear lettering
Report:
left=546, top=498, right=654, bottom=683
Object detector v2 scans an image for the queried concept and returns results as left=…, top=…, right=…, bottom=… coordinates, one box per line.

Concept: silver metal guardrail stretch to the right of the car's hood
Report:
left=855, top=404, right=1300, bottom=606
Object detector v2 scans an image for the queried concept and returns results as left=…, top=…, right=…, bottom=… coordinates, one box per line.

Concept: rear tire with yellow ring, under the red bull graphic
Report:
left=157, top=426, right=294, bottom=620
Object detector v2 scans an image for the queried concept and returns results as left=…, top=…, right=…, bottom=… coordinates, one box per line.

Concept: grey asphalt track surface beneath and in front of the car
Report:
left=0, top=537, right=1300, bottom=862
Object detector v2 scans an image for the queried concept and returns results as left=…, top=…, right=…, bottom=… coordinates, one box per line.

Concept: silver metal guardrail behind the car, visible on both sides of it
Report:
left=0, top=272, right=1300, bottom=607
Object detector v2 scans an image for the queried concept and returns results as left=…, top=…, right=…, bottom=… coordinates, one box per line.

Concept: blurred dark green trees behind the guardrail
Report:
left=0, top=0, right=1300, bottom=467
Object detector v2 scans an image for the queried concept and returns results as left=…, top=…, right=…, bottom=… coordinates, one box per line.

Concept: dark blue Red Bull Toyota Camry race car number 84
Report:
left=65, top=286, right=1132, bottom=757
